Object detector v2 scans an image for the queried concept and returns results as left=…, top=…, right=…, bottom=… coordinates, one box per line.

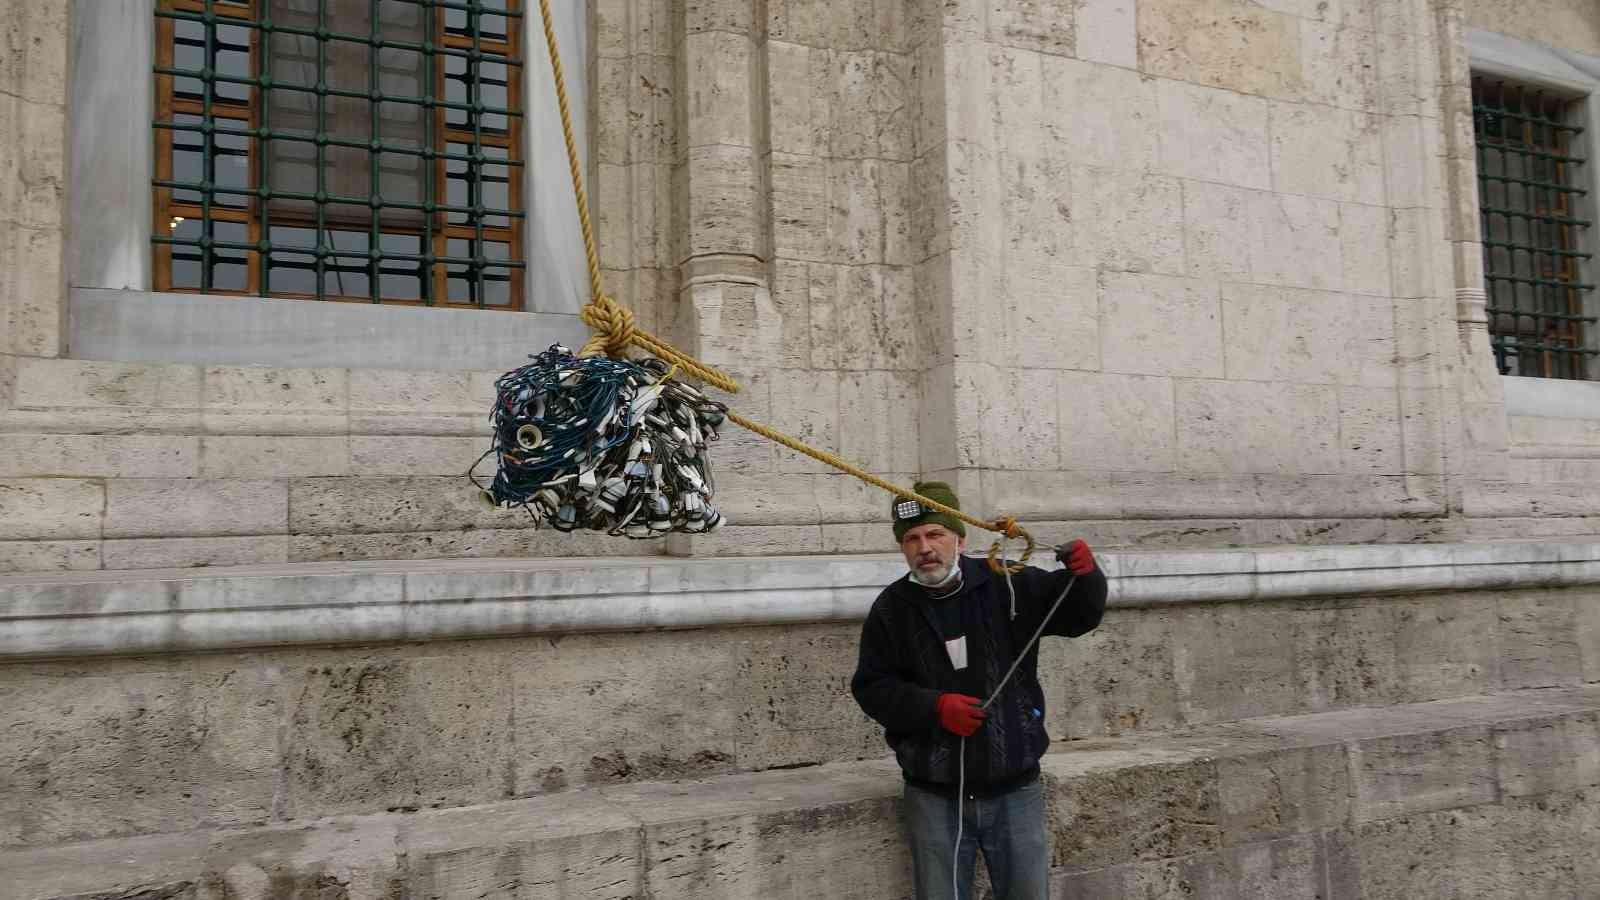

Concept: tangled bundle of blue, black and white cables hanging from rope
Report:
left=478, top=344, right=728, bottom=538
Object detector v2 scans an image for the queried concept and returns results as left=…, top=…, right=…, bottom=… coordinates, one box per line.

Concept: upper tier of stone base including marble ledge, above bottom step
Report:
left=0, top=541, right=1600, bottom=847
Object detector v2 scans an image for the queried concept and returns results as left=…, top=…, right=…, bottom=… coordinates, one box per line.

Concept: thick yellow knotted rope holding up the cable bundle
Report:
left=539, top=0, right=1034, bottom=572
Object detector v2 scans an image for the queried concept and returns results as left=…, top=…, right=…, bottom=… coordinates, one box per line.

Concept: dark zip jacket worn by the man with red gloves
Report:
left=850, top=557, right=1106, bottom=794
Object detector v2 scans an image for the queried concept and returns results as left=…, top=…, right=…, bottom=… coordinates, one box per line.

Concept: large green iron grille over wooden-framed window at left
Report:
left=154, top=0, right=526, bottom=309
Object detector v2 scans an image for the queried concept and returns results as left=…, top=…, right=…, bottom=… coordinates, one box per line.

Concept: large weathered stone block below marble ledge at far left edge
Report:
left=0, top=658, right=285, bottom=846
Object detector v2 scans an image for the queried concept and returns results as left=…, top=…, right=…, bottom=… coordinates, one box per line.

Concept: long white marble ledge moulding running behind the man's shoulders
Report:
left=0, top=540, right=1600, bottom=658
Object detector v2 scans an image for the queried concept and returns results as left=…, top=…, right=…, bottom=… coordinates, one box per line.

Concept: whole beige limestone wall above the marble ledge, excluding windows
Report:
left=0, top=0, right=1600, bottom=570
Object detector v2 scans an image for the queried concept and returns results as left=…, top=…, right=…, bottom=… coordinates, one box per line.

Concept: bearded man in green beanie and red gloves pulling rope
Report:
left=850, top=482, right=1106, bottom=900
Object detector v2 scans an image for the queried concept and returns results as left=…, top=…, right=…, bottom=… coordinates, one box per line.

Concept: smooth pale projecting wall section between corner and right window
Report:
left=925, top=0, right=1478, bottom=531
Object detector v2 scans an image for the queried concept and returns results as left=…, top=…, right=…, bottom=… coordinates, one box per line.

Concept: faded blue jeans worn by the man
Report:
left=904, top=781, right=1050, bottom=900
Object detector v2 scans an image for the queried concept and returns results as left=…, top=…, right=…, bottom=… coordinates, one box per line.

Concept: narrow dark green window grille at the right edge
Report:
left=1472, top=77, right=1600, bottom=380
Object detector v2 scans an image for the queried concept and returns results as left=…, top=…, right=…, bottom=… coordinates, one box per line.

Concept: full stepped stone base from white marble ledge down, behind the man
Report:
left=0, top=541, right=1600, bottom=900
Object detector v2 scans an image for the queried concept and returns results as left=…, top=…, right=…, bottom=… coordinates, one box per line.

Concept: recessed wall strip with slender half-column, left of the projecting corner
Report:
left=636, top=0, right=938, bottom=554
